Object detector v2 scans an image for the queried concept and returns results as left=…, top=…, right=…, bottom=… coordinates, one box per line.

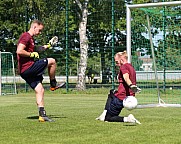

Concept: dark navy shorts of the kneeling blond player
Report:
left=107, top=96, right=124, bottom=116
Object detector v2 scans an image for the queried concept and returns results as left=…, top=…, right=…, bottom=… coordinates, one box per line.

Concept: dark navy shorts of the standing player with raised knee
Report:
left=20, top=58, right=48, bottom=89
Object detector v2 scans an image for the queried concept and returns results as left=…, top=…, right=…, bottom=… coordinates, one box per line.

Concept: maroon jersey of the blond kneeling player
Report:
left=115, top=63, right=136, bottom=100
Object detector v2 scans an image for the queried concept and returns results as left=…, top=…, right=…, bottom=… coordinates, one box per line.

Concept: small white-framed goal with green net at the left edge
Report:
left=0, top=52, right=17, bottom=95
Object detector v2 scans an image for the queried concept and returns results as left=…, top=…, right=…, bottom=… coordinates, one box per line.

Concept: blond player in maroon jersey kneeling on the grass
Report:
left=96, top=51, right=141, bottom=124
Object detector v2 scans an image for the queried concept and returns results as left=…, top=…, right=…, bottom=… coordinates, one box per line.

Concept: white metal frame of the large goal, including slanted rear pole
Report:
left=126, top=1, right=181, bottom=108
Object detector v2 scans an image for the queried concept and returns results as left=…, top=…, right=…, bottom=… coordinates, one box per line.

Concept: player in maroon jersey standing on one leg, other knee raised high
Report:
left=16, top=20, right=65, bottom=122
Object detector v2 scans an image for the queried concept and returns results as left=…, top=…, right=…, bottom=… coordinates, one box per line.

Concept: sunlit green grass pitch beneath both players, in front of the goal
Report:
left=0, top=89, right=181, bottom=144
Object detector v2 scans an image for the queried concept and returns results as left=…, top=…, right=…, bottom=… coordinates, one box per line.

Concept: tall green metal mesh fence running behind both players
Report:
left=0, top=0, right=181, bottom=94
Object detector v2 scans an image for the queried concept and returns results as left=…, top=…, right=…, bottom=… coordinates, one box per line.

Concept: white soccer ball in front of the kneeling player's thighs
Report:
left=123, top=96, right=138, bottom=110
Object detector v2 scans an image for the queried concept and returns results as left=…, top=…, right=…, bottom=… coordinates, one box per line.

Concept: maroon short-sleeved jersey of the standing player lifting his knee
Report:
left=17, top=32, right=34, bottom=73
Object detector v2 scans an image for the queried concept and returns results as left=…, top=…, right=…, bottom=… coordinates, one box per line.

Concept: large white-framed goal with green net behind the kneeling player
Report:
left=127, top=1, right=181, bottom=108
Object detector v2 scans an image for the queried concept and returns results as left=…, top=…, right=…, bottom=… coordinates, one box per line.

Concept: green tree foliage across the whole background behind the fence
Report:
left=0, top=0, right=181, bottom=74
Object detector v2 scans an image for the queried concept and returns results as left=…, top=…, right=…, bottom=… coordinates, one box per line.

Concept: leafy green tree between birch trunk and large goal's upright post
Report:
left=87, top=0, right=126, bottom=83
